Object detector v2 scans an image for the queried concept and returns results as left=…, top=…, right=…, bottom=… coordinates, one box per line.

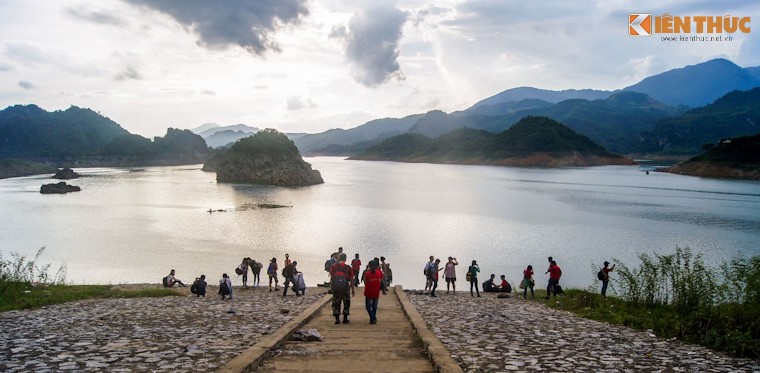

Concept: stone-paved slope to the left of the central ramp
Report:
left=0, top=287, right=324, bottom=372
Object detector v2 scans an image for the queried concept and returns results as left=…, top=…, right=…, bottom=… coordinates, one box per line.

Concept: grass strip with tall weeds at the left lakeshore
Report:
left=0, top=247, right=179, bottom=311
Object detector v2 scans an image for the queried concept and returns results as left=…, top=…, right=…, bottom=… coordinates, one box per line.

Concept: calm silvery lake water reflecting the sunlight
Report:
left=0, top=158, right=760, bottom=289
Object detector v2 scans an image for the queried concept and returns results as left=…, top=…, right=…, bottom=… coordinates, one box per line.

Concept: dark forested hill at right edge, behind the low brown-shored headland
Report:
left=640, top=87, right=760, bottom=155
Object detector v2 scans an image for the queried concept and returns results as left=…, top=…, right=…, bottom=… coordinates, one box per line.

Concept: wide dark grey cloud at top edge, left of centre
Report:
left=125, top=0, right=309, bottom=55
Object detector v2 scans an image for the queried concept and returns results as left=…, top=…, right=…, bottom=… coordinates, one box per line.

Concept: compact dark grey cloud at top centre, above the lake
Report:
left=330, top=2, right=409, bottom=87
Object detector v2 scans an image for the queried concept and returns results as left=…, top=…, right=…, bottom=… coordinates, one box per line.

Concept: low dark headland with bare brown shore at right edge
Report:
left=665, top=133, right=760, bottom=180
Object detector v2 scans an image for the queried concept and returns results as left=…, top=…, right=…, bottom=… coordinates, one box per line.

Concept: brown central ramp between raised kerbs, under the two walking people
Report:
left=258, top=288, right=434, bottom=373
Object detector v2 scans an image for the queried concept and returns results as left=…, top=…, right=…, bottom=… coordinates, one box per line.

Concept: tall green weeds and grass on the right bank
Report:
left=536, top=248, right=760, bottom=359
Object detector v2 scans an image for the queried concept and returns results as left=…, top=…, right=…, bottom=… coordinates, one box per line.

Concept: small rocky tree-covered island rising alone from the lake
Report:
left=203, top=128, right=324, bottom=187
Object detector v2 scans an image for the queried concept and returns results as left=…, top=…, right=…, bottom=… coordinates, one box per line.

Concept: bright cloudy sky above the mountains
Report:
left=0, top=0, right=760, bottom=137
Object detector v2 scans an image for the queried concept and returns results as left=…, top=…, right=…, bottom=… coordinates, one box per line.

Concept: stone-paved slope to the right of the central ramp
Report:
left=409, top=291, right=760, bottom=372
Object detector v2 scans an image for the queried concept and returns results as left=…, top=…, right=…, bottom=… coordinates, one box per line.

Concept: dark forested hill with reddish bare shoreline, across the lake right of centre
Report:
left=350, top=116, right=633, bottom=167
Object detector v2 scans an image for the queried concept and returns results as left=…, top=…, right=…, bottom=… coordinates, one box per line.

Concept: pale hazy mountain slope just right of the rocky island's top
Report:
left=293, top=114, right=422, bottom=154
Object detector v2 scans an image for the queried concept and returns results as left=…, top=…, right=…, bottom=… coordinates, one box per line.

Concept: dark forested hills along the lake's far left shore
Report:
left=0, top=105, right=208, bottom=166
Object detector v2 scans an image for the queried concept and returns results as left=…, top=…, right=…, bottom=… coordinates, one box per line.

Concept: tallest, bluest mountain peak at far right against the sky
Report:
left=623, top=58, right=760, bottom=107
